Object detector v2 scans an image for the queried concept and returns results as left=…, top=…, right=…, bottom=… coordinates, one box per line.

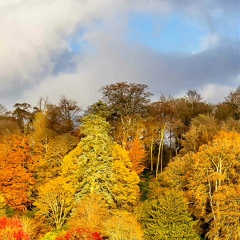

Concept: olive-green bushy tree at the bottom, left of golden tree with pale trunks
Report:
left=141, top=190, right=199, bottom=240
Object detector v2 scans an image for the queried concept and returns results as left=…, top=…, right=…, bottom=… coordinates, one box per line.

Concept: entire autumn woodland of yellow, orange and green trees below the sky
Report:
left=0, top=82, right=240, bottom=240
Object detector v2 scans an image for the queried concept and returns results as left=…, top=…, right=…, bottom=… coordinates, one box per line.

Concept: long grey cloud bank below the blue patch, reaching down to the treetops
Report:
left=19, top=33, right=240, bottom=107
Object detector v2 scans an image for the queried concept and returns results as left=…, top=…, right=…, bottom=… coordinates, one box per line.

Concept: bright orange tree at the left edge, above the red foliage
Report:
left=0, top=135, right=35, bottom=210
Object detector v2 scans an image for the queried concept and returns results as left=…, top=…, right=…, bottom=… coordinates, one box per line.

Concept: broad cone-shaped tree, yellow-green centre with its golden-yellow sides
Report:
left=62, top=115, right=140, bottom=210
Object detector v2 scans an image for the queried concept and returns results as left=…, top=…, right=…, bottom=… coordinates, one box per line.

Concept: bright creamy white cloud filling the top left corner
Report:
left=0, top=0, right=125, bottom=88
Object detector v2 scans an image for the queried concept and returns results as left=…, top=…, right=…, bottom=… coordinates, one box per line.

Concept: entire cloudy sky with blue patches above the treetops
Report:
left=0, top=0, right=240, bottom=109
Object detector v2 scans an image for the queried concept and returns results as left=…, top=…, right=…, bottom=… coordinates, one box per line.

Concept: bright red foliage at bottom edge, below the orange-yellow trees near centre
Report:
left=56, top=228, right=102, bottom=240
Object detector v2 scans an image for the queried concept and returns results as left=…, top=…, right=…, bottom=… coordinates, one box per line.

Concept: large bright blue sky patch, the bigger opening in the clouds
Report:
left=126, top=13, right=208, bottom=53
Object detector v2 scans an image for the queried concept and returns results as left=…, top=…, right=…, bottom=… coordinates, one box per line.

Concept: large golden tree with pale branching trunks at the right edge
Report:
left=187, top=132, right=240, bottom=240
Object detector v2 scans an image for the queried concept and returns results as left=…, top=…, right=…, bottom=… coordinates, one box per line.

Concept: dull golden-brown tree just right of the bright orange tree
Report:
left=31, top=112, right=77, bottom=185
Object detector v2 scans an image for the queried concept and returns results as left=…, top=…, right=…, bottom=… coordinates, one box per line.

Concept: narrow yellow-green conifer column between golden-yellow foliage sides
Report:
left=77, top=115, right=114, bottom=203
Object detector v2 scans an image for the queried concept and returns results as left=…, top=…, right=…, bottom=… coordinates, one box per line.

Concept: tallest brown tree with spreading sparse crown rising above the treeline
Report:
left=100, top=82, right=152, bottom=148
